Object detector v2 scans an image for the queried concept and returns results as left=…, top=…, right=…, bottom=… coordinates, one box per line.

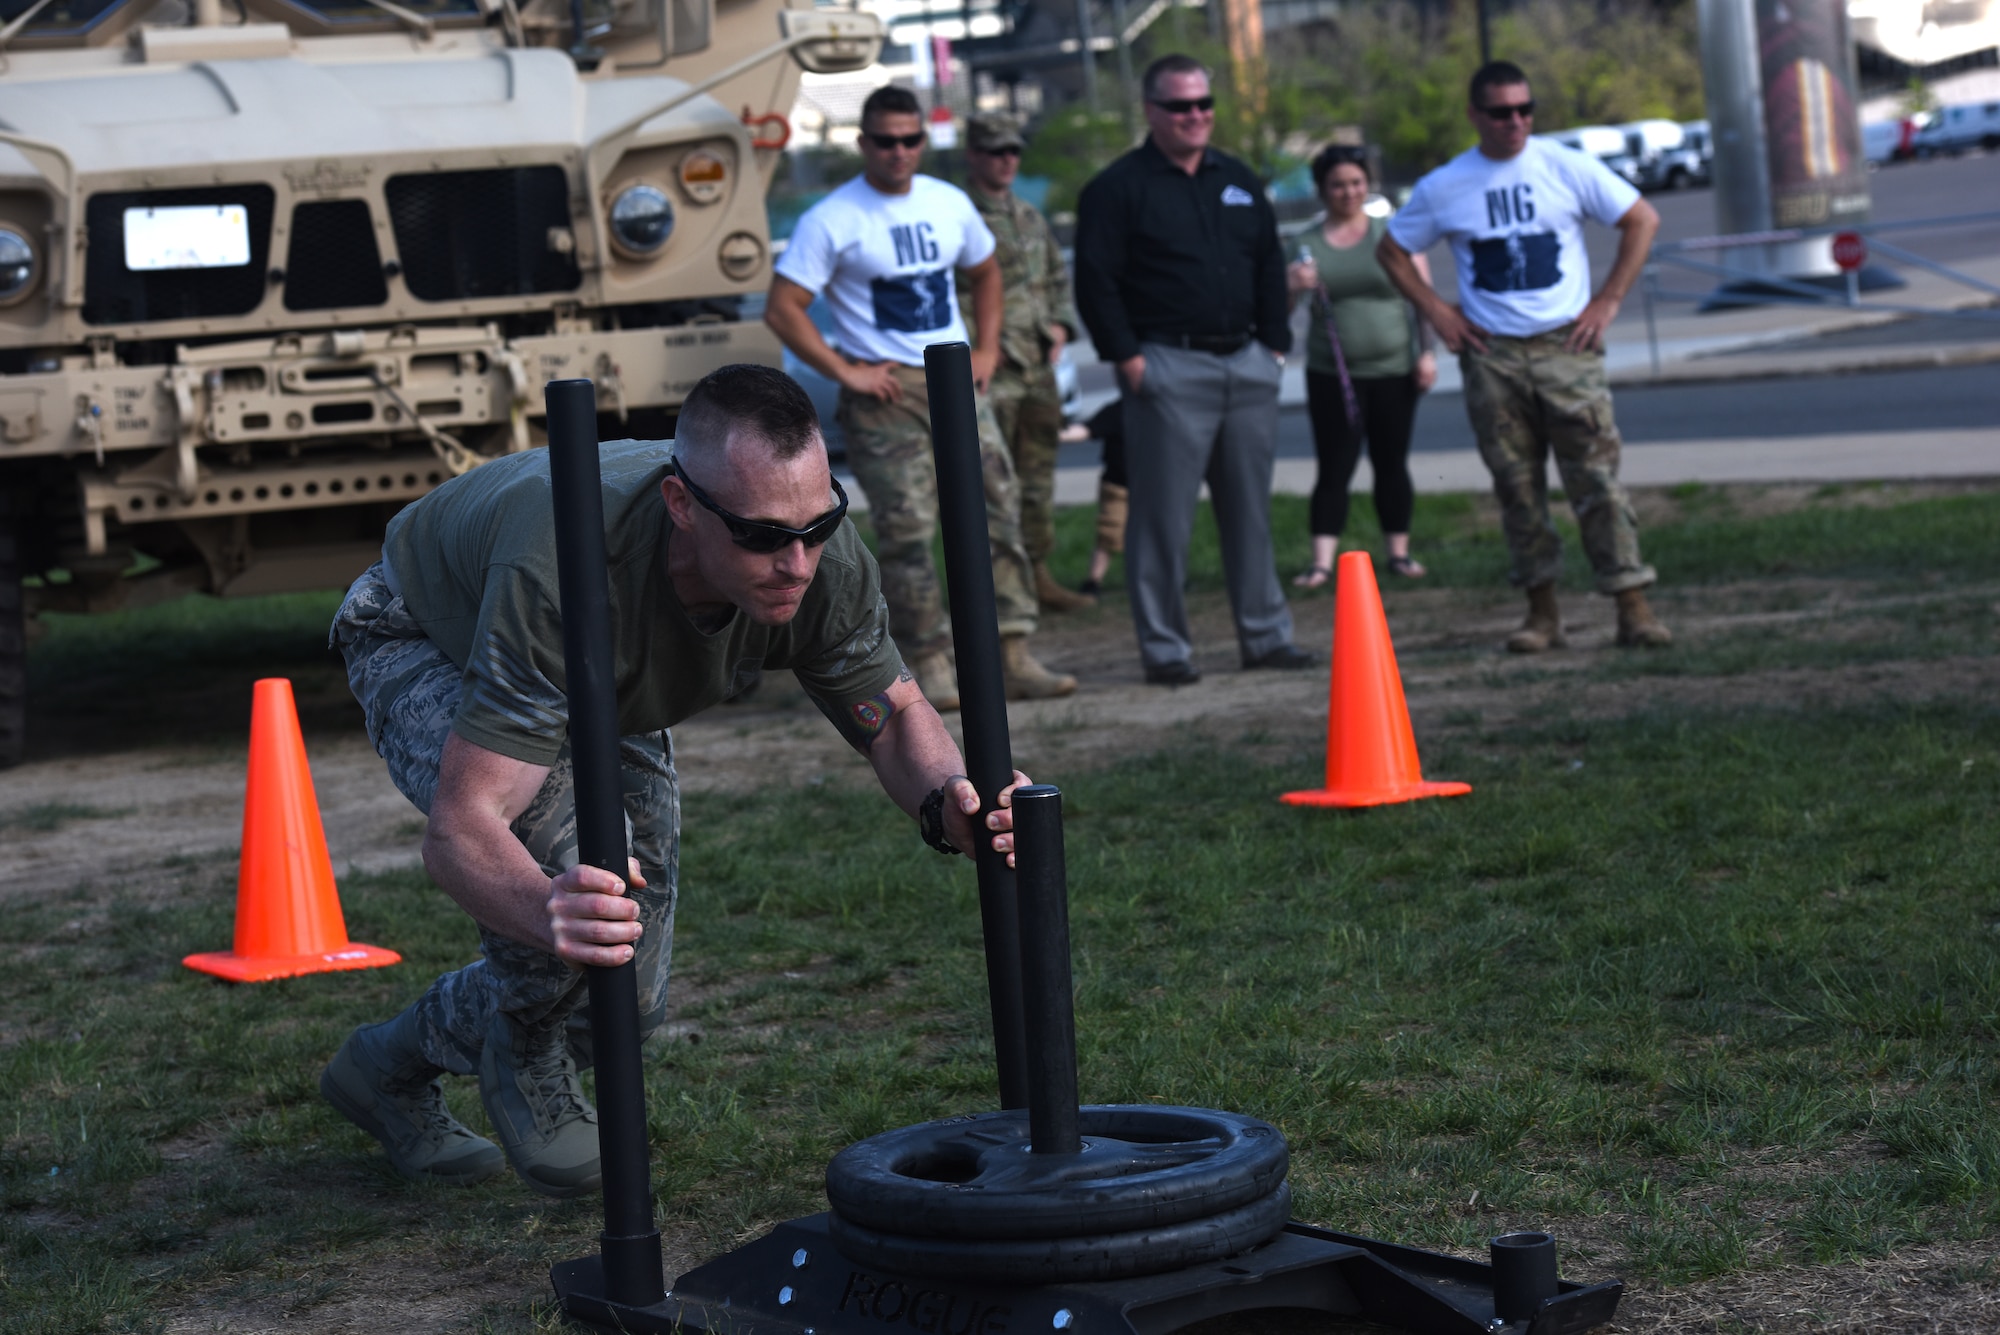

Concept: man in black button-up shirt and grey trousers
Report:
left=1076, top=56, right=1312, bottom=685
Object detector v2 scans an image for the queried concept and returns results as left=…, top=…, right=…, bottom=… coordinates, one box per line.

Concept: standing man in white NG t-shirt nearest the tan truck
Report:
left=764, top=88, right=1076, bottom=709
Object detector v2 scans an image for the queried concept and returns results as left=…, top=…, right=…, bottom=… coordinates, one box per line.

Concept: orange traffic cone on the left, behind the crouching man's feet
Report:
left=182, top=677, right=402, bottom=983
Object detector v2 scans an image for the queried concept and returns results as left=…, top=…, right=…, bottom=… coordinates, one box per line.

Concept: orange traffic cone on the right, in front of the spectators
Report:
left=1284, top=552, right=1472, bottom=807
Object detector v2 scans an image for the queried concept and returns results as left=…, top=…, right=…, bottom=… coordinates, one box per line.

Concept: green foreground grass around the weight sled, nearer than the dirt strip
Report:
left=0, top=705, right=2000, bottom=1333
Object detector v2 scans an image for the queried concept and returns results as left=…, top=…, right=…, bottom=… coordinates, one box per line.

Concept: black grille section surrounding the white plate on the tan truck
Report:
left=84, top=186, right=272, bottom=324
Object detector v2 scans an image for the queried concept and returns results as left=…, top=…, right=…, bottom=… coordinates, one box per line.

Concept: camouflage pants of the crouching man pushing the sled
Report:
left=332, top=564, right=680, bottom=1075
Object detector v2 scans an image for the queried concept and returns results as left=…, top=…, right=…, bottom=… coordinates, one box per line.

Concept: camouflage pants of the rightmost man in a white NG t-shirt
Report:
left=1458, top=326, right=1656, bottom=594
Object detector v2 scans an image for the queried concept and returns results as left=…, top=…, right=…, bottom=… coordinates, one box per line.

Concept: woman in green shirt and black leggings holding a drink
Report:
left=1288, top=144, right=1438, bottom=590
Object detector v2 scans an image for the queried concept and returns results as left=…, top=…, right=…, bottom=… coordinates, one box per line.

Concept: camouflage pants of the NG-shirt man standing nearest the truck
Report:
left=838, top=366, right=1040, bottom=660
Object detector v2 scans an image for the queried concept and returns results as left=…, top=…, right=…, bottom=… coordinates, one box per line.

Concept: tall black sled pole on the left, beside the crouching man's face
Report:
left=546, top=380, right=666, bottom=1307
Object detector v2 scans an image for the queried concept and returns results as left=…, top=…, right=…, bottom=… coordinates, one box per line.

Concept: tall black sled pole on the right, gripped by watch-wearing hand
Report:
left=924, top=344, right=1028, bottom=1107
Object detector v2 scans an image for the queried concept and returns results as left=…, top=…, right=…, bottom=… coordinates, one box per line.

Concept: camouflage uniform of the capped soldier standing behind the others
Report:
left=966, top=176, right=1076, bottom=562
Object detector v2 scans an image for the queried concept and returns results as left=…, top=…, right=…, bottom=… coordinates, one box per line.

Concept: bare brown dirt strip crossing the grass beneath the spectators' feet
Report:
left=0, top=578, right=2000, bottom=901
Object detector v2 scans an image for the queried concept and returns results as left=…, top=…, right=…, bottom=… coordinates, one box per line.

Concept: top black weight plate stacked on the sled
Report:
left=826, top=1105, right=1290, bottom=1241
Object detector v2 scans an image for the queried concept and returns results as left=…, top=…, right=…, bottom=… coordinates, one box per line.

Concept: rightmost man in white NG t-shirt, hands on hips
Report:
left=1376, top=60, right=1672, bottom=654
